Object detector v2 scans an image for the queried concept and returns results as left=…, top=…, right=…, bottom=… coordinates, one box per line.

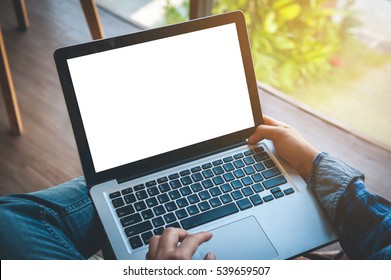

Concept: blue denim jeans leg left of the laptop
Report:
left=0, top=177, right=107, bottom=260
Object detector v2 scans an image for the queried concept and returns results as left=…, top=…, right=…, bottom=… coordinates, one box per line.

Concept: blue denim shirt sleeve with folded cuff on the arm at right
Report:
left=308, top=153, right=391, bottom=259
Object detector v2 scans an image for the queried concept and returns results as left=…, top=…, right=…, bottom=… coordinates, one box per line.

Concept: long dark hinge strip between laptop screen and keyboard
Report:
left=117, top=140, right=247, bottom=184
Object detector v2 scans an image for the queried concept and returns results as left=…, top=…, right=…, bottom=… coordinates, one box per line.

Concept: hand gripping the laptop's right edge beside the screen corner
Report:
left=248, top=115, right=319, bottom=180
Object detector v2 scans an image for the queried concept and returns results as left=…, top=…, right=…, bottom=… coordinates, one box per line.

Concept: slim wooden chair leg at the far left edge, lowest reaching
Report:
left=0, top=28, right=23, bottom=135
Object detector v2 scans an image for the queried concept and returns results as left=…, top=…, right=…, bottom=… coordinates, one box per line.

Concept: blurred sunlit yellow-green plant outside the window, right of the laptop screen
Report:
left=213, top=0, right=351, bottom=92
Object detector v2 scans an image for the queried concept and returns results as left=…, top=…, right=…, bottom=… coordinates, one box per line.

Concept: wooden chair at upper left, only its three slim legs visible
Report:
left=0, top=0, right=104, bottom=135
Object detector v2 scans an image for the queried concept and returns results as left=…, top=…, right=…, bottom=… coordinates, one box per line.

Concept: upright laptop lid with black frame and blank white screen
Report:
left=54, top=11, right=262, bottom=187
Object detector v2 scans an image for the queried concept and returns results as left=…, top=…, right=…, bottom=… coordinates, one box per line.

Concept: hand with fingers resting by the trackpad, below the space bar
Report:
left=146, top=228, right=216, bottom=260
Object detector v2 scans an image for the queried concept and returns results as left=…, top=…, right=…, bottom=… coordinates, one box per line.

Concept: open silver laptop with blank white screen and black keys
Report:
left=54, top=11, right=337, bottom=259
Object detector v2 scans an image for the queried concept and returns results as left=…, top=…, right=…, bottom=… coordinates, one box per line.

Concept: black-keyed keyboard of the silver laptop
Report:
left=109, top=147, right=294, bottom=249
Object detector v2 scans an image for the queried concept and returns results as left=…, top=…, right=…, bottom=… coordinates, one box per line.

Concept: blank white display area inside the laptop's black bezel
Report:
left=67, top=23, right=254, bottom=172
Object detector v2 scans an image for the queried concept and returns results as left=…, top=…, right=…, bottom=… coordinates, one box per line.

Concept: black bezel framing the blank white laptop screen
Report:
left=54, top=11, right=262, bottom=188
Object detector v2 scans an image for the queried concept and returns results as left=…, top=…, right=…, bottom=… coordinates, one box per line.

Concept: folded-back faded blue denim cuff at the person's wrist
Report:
left=307, top=152, right=364, bottom=222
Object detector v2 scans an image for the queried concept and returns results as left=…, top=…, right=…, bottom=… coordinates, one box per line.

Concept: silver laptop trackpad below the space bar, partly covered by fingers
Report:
left=197, top=216, right=278, bottom=260
